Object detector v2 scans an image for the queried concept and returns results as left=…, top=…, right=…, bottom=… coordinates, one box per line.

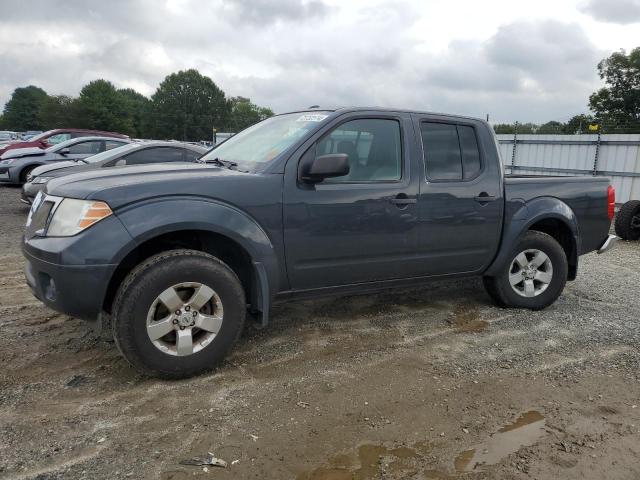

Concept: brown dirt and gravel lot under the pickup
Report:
left=0, top=187, right=640, bottom=480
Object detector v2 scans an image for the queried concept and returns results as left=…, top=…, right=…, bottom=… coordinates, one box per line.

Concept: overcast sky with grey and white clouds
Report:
left=0, top=0, right=640, bottom=122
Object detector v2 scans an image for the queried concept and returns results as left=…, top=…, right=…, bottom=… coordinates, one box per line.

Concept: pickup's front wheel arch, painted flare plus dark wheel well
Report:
left=103, top=199, right=279, bottom=324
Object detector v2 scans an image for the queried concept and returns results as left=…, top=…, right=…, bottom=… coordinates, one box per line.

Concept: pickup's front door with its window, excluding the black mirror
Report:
left=283, top=115, right=418, bottom=290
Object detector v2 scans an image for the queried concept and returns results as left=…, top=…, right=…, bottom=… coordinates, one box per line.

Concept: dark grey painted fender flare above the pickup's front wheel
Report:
left=114, top=196, right=280, bottom=325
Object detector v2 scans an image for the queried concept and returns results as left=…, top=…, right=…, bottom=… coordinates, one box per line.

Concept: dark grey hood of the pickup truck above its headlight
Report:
left=46, top=163, right=248, bottom=209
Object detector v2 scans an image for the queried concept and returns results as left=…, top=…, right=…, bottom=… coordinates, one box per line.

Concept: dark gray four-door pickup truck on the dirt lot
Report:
left=23, top=108, right=616, bottom=378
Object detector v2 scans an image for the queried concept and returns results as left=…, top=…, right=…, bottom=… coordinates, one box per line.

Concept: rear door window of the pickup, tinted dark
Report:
left=420, top=122, right=482, bottom=181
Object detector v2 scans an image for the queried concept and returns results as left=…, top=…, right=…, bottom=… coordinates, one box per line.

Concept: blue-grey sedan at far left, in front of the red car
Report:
left=0, top=137, right=130, bottom=184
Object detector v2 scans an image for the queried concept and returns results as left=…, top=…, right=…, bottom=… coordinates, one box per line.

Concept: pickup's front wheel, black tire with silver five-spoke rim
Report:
left=111, top=250, right=246, bottom=379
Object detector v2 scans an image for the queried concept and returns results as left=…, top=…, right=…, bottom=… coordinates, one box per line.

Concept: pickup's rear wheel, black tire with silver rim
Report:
left=483, top=231, right=568, bottom=310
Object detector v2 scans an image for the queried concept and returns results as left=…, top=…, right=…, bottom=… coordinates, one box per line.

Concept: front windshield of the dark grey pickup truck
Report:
left=200, top=111, right=329, bottom=170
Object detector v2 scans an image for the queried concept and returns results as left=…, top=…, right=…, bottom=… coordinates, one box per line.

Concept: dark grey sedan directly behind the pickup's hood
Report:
left=22, top=141, right=208, bottom=203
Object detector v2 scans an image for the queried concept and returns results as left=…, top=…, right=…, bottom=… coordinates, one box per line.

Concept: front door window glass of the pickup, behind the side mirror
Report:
left=316, top=118, right=402, bottom=183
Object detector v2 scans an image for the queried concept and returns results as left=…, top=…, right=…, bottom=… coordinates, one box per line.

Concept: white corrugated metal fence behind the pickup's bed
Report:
left=498, top=134, right=640, bottom=203
